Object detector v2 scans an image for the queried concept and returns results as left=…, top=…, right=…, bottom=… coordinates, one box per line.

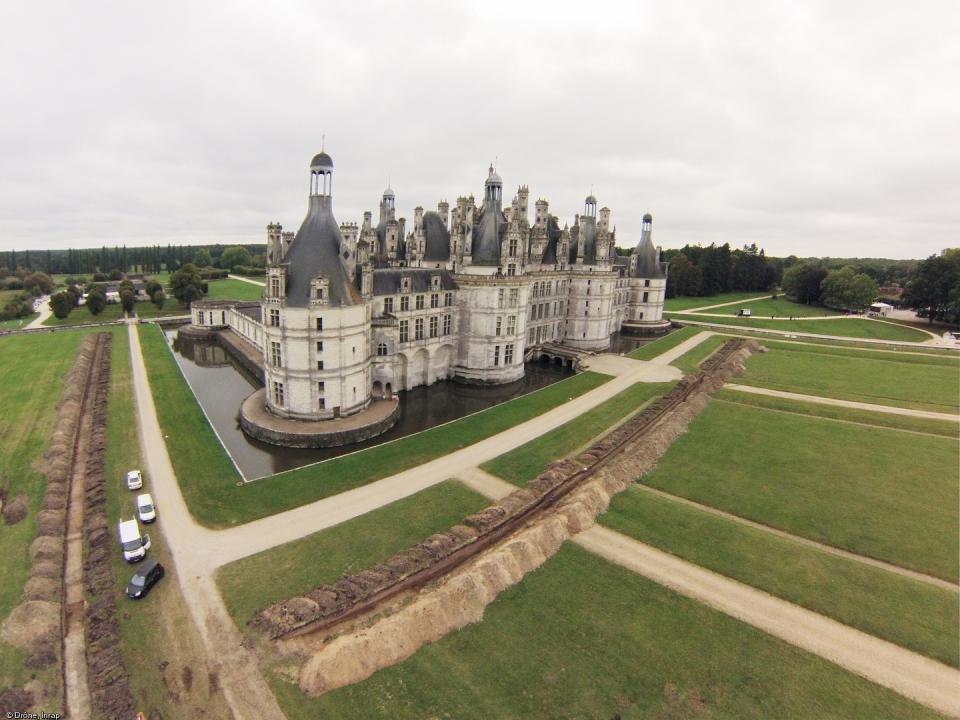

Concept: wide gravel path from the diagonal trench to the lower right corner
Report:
left=573, top=526, right=960, bottom=717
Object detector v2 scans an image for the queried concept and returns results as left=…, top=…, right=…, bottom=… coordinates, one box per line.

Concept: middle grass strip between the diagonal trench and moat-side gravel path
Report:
left=481, top=383, right=673, bottom=486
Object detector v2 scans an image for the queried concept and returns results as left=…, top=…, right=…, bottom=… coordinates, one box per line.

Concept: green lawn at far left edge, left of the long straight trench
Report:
left=0, top=333, right=93, bottom=709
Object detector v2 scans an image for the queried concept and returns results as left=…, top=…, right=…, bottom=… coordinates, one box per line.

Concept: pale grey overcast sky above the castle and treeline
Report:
left=0, top=0, right=960, bottom=258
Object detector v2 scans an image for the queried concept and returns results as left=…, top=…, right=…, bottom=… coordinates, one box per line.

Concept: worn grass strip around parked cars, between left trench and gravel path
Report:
left=104, top=327, right=227, bottom=720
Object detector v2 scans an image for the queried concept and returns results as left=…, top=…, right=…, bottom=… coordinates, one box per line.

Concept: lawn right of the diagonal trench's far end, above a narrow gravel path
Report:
left=735, top=346, right=960, bottom=412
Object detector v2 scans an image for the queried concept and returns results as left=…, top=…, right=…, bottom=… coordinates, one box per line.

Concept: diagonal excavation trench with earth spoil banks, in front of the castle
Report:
left=252, top=339, right=757, bottom=695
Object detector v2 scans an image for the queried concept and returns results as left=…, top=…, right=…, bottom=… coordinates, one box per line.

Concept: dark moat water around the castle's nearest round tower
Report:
left=166, top=330, right=571, bottom=479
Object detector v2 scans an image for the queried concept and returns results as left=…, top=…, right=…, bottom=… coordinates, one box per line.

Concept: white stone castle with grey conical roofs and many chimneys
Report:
left=192, top=152, right=669, bottom=442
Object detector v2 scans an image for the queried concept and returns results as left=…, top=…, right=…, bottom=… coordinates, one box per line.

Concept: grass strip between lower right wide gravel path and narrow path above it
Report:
left=600, top=487, right=960, bottom=667
